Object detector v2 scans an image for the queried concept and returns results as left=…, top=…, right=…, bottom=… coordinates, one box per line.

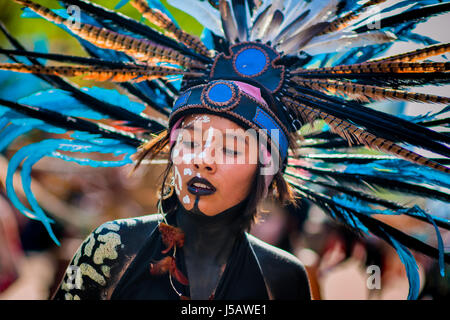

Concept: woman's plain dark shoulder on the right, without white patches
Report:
left=247, top=234, right=311, bottom=300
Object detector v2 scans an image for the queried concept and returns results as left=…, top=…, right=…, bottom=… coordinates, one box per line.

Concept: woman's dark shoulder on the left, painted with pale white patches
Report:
left=54, top=214, right=161, bottom=300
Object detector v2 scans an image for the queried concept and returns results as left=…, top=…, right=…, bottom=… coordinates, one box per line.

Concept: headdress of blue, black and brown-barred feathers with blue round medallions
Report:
left=0, top=0, right=450, bottom=298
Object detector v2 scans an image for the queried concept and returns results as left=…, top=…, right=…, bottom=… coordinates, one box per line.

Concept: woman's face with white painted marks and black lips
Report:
left=171, top=114, right=258, bottom=216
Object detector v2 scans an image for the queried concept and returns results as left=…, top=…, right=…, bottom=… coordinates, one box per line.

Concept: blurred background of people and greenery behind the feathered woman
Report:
left=0, top=0, right=450, bottom=299
